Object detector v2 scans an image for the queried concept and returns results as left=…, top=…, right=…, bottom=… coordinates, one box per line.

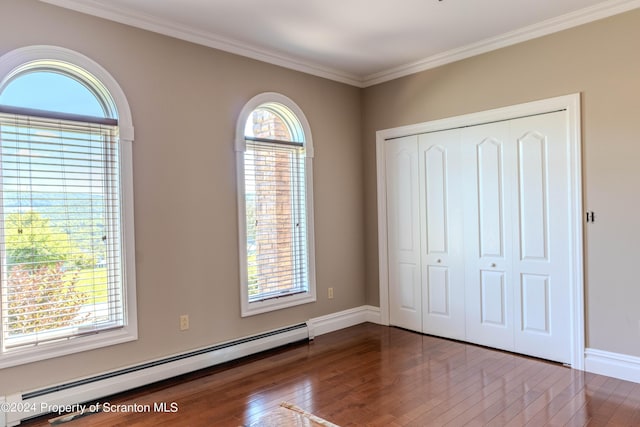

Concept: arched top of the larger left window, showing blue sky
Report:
left=0, top=46, right=133, bottom=141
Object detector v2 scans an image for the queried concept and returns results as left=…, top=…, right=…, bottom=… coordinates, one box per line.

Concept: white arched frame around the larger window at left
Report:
left=0, top=45, right=138, bottom=369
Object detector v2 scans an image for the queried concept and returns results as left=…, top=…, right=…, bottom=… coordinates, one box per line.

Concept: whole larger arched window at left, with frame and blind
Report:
left=0, top=46, right=137, bottom=368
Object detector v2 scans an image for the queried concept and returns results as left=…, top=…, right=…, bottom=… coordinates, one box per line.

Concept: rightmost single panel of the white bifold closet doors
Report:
left=510, top=112, right=571, bottom=363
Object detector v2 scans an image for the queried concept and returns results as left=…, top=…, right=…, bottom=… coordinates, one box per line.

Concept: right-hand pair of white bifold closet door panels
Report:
left=462, top=112, right=571, bottom=363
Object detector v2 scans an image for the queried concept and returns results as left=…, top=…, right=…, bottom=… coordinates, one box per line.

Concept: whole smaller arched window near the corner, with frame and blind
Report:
left=236, top=93, right=316, bottom=316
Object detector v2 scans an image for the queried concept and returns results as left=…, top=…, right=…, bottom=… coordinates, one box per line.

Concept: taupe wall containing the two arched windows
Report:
left=0, top=0, right=365, bottom=395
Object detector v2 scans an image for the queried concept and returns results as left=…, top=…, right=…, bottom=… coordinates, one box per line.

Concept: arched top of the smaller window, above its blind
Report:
left=236, top=92, right=313, bottom=157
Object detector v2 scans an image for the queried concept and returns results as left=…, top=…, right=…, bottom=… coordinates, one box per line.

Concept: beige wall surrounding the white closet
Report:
left=363, top=9, right=640, bottom=356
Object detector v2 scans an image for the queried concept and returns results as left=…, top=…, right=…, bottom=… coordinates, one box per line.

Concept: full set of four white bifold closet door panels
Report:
left=385, top=112, right=571, bottom=363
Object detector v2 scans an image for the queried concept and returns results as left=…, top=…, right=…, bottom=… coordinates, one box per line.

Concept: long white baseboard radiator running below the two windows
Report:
left=0, top=323, right=312, bottom=427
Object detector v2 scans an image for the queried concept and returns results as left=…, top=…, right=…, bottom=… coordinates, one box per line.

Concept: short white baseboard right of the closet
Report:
left=585, top=348, right=640, bottom=383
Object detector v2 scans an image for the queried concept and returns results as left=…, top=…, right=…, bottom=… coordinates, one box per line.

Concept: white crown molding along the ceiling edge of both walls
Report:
left=40, top=0, right=640, bottom=88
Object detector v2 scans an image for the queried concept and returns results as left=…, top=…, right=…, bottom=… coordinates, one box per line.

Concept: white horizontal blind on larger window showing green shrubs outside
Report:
left=0, top=113, right=125, bottom=350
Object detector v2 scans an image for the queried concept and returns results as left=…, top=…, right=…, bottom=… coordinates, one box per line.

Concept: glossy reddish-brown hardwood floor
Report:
left=23, top=324, right=640, bottom=427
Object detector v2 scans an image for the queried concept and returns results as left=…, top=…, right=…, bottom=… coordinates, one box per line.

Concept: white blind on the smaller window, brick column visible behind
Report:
left=244, top=138, right=309, bottom=302
